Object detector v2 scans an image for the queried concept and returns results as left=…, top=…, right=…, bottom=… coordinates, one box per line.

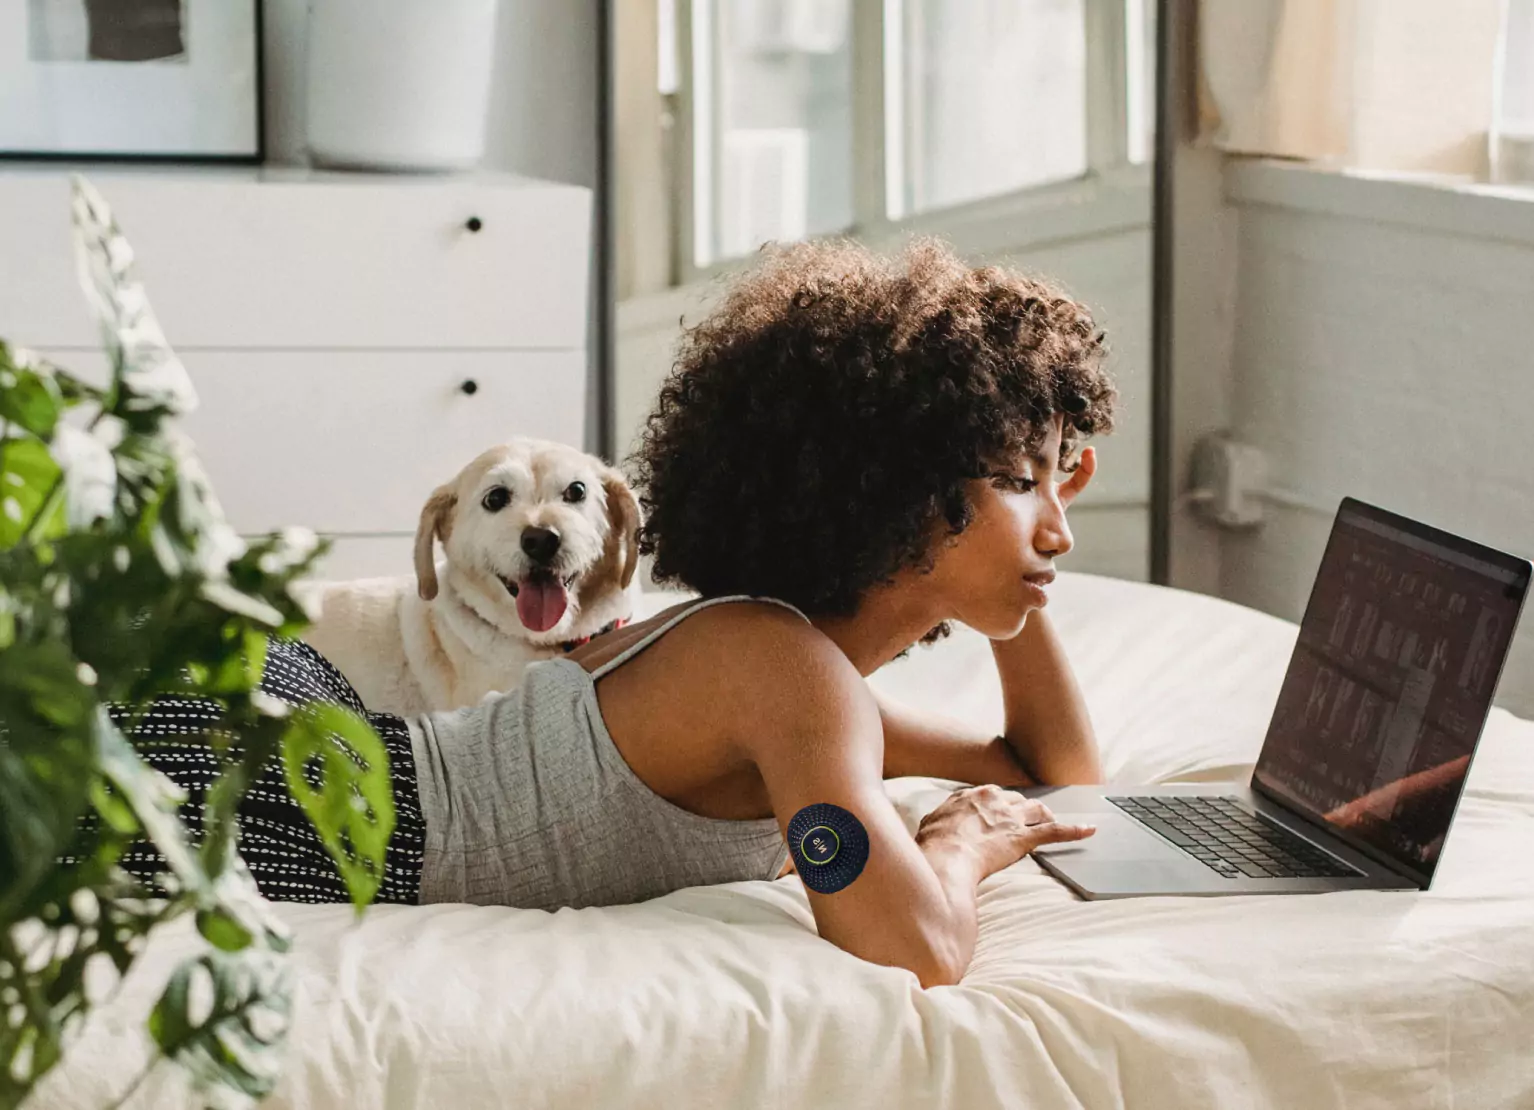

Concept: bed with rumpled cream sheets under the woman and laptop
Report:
left=35, top=573, right=1534, bottom=1110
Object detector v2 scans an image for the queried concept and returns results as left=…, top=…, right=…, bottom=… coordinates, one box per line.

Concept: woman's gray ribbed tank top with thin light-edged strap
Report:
left=410, top=596, right=808, bottom=909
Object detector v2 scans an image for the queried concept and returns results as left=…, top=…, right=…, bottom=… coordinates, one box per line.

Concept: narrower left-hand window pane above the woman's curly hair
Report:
left=692, top=0, right=853, bottom=265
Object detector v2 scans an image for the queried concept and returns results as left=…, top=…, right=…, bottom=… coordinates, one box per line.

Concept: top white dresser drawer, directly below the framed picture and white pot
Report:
left=0, top=170, right=591, bottom=351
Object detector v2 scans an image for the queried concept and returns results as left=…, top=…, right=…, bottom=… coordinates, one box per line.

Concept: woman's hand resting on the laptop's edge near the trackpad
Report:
left=916, top=785, right=1097, bottom=882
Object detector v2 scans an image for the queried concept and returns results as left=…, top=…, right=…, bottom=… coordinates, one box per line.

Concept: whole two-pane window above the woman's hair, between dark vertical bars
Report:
left=658, top=0, right=1155, bottom=279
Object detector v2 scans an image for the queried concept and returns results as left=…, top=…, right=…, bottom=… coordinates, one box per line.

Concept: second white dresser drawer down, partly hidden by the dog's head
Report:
left=44, top=351, right=586, bottom=535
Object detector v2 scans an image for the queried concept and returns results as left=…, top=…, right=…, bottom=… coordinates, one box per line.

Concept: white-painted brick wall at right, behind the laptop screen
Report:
left=1220, top=163, right=1534, bottom=714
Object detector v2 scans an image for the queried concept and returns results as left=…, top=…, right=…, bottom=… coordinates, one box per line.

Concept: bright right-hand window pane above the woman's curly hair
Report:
left=885, top=0, right=1086, bottom=216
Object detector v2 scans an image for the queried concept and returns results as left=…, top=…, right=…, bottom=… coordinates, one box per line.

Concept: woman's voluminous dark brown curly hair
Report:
left=630, top=239, right=1117, bottom=615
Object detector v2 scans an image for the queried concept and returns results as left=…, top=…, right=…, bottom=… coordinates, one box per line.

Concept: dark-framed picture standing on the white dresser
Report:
left=0, top=0, right=262, bottom=163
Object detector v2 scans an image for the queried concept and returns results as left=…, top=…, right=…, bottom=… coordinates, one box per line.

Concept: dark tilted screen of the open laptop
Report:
left=1253, top=498, right=1529, bottom=882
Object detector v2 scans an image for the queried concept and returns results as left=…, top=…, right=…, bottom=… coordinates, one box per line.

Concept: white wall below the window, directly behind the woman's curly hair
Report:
left=614, top=167, right=1151, bottom=580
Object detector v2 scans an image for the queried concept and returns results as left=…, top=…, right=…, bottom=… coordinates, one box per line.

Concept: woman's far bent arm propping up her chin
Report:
left=876, top=610, right=1103, bottom=787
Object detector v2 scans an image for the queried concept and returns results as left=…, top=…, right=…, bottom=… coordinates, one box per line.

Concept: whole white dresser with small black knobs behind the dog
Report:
left=0, top=169, right=591, bottom=578
